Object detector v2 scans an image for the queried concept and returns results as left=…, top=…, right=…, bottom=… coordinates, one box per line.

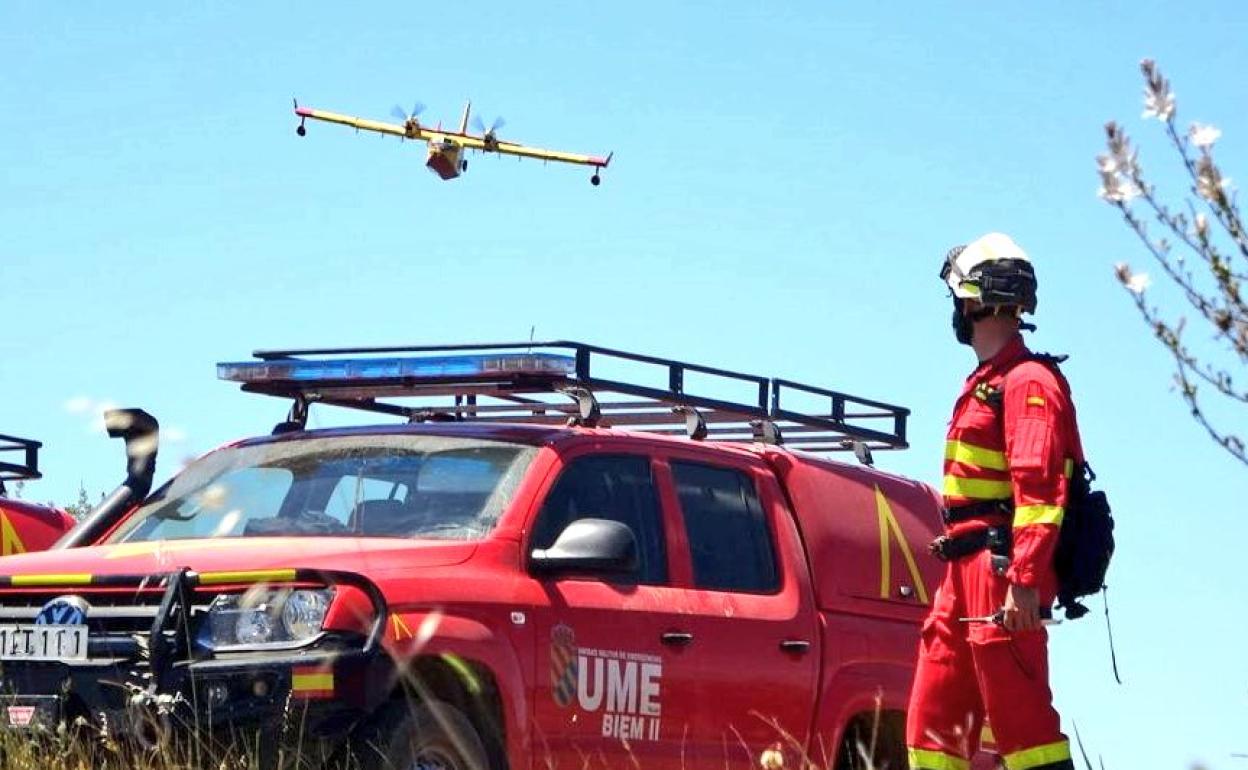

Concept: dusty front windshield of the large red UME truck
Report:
left=109, top=436, right=535, bottom=543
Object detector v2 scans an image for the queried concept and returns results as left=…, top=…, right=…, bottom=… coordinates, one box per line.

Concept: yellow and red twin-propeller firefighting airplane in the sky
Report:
left=295, top=100, right=614, bottom=187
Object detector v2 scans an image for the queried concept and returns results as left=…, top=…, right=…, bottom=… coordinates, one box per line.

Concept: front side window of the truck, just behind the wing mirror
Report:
left=530, top=454, right=668, bottom=585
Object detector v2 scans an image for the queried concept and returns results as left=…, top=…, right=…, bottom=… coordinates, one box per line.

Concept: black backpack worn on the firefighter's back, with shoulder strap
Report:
left=997, top=353, right=1113, bottom=620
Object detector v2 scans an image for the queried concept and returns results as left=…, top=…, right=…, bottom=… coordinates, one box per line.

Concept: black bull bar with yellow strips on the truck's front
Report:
left=0, top=568, right=393, bottom=738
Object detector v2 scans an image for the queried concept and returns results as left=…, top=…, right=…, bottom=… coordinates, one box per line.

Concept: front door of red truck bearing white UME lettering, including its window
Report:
left=525, top=453, right=693, bottom=770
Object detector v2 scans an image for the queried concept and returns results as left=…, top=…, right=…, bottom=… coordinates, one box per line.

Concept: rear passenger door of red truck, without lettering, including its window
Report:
left=664, top=457, right=830, bottom=768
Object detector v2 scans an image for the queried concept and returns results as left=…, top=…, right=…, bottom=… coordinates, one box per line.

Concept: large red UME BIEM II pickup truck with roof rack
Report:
left=0, top=342, right=940, bottom=770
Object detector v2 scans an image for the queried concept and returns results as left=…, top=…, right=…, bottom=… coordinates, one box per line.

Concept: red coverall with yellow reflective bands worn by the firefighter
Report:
left=906, top=334, right=1082, bottom=770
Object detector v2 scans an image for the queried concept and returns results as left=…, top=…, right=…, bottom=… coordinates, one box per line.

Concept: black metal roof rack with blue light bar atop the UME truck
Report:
left=217, top=341, right=910, bottom=452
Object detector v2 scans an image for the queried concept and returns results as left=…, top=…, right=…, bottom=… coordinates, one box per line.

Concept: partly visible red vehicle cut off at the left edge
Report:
left=0, top=436, right=74, bottom=557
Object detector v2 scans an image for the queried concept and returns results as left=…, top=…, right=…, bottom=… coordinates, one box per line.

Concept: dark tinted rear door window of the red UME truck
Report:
left=671, top=462, right=780, bottom=593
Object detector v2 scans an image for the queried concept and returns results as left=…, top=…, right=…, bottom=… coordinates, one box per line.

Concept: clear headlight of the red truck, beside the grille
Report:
left=198, top=588, right=333, bottom=649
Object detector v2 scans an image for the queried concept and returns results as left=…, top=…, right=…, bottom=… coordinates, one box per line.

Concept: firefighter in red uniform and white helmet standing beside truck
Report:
left=906, top=233, right=1082, bottom=770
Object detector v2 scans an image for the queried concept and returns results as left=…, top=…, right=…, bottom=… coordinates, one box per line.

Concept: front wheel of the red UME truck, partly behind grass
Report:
left=352, top=700, right=489, bottom=770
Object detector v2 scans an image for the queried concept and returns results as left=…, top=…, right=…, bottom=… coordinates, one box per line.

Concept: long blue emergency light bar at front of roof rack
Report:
left=217, top=353, right=577, bottom=384
